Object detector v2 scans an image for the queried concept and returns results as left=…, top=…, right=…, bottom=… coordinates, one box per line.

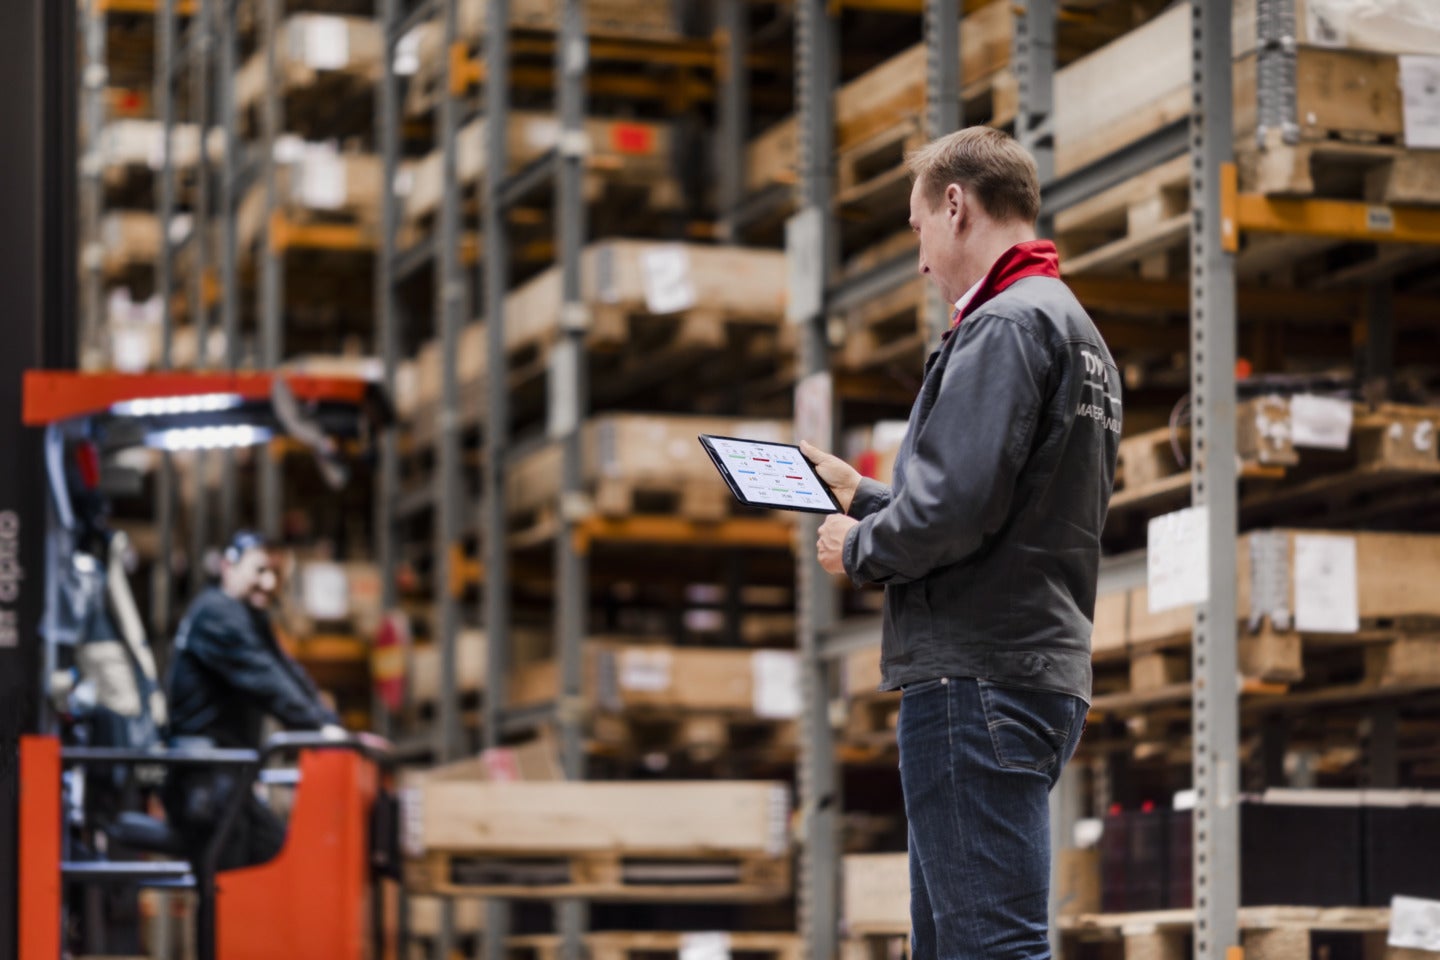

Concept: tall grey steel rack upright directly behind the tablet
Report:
left=795, top=0, right=840, bottom=960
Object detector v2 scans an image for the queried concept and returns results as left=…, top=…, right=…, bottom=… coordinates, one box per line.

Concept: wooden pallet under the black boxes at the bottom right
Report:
left=1060, top=907, right=1426, bottom=960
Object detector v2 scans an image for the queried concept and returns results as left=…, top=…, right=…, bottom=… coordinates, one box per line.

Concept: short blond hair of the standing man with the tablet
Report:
left=906, top=127, right=1040, bottom=223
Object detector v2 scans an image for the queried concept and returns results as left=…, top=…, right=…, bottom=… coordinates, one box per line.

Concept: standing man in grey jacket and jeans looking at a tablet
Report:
left=805, top=127, right=1122, bottom=960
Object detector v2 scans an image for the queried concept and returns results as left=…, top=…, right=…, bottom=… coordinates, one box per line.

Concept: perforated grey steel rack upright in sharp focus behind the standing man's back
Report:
left=1189, top=0, right=1240, bottom=960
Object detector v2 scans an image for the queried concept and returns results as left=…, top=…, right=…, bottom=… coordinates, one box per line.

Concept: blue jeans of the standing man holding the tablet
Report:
left=897, top=678, right=1086, bottom=960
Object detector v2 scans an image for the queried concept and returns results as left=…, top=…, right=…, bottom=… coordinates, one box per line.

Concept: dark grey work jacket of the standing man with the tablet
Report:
left=844, top=245, right=1122, bottom=701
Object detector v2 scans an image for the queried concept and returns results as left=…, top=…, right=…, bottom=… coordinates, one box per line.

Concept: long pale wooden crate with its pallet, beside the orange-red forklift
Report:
left=403, top=769, right=791, bottom=902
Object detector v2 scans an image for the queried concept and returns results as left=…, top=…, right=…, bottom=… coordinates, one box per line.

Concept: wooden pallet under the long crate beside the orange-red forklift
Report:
left=406, top=851, right=791, bottom=902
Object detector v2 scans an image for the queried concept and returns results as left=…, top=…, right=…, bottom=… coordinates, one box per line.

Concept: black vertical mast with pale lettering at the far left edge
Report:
left=0, top=0, right=78, bottom=960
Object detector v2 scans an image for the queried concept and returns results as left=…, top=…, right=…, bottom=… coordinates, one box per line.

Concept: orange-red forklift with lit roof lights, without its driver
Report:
left=17, top=371, right=399, bottom=960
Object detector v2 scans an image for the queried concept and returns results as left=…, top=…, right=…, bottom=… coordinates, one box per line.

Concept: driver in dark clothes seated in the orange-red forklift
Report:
left=164, top=533, right=346, bottom=869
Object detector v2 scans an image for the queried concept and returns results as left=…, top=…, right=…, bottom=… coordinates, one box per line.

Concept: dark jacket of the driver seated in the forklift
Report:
left=166, top=589, right=337, bottom=750
